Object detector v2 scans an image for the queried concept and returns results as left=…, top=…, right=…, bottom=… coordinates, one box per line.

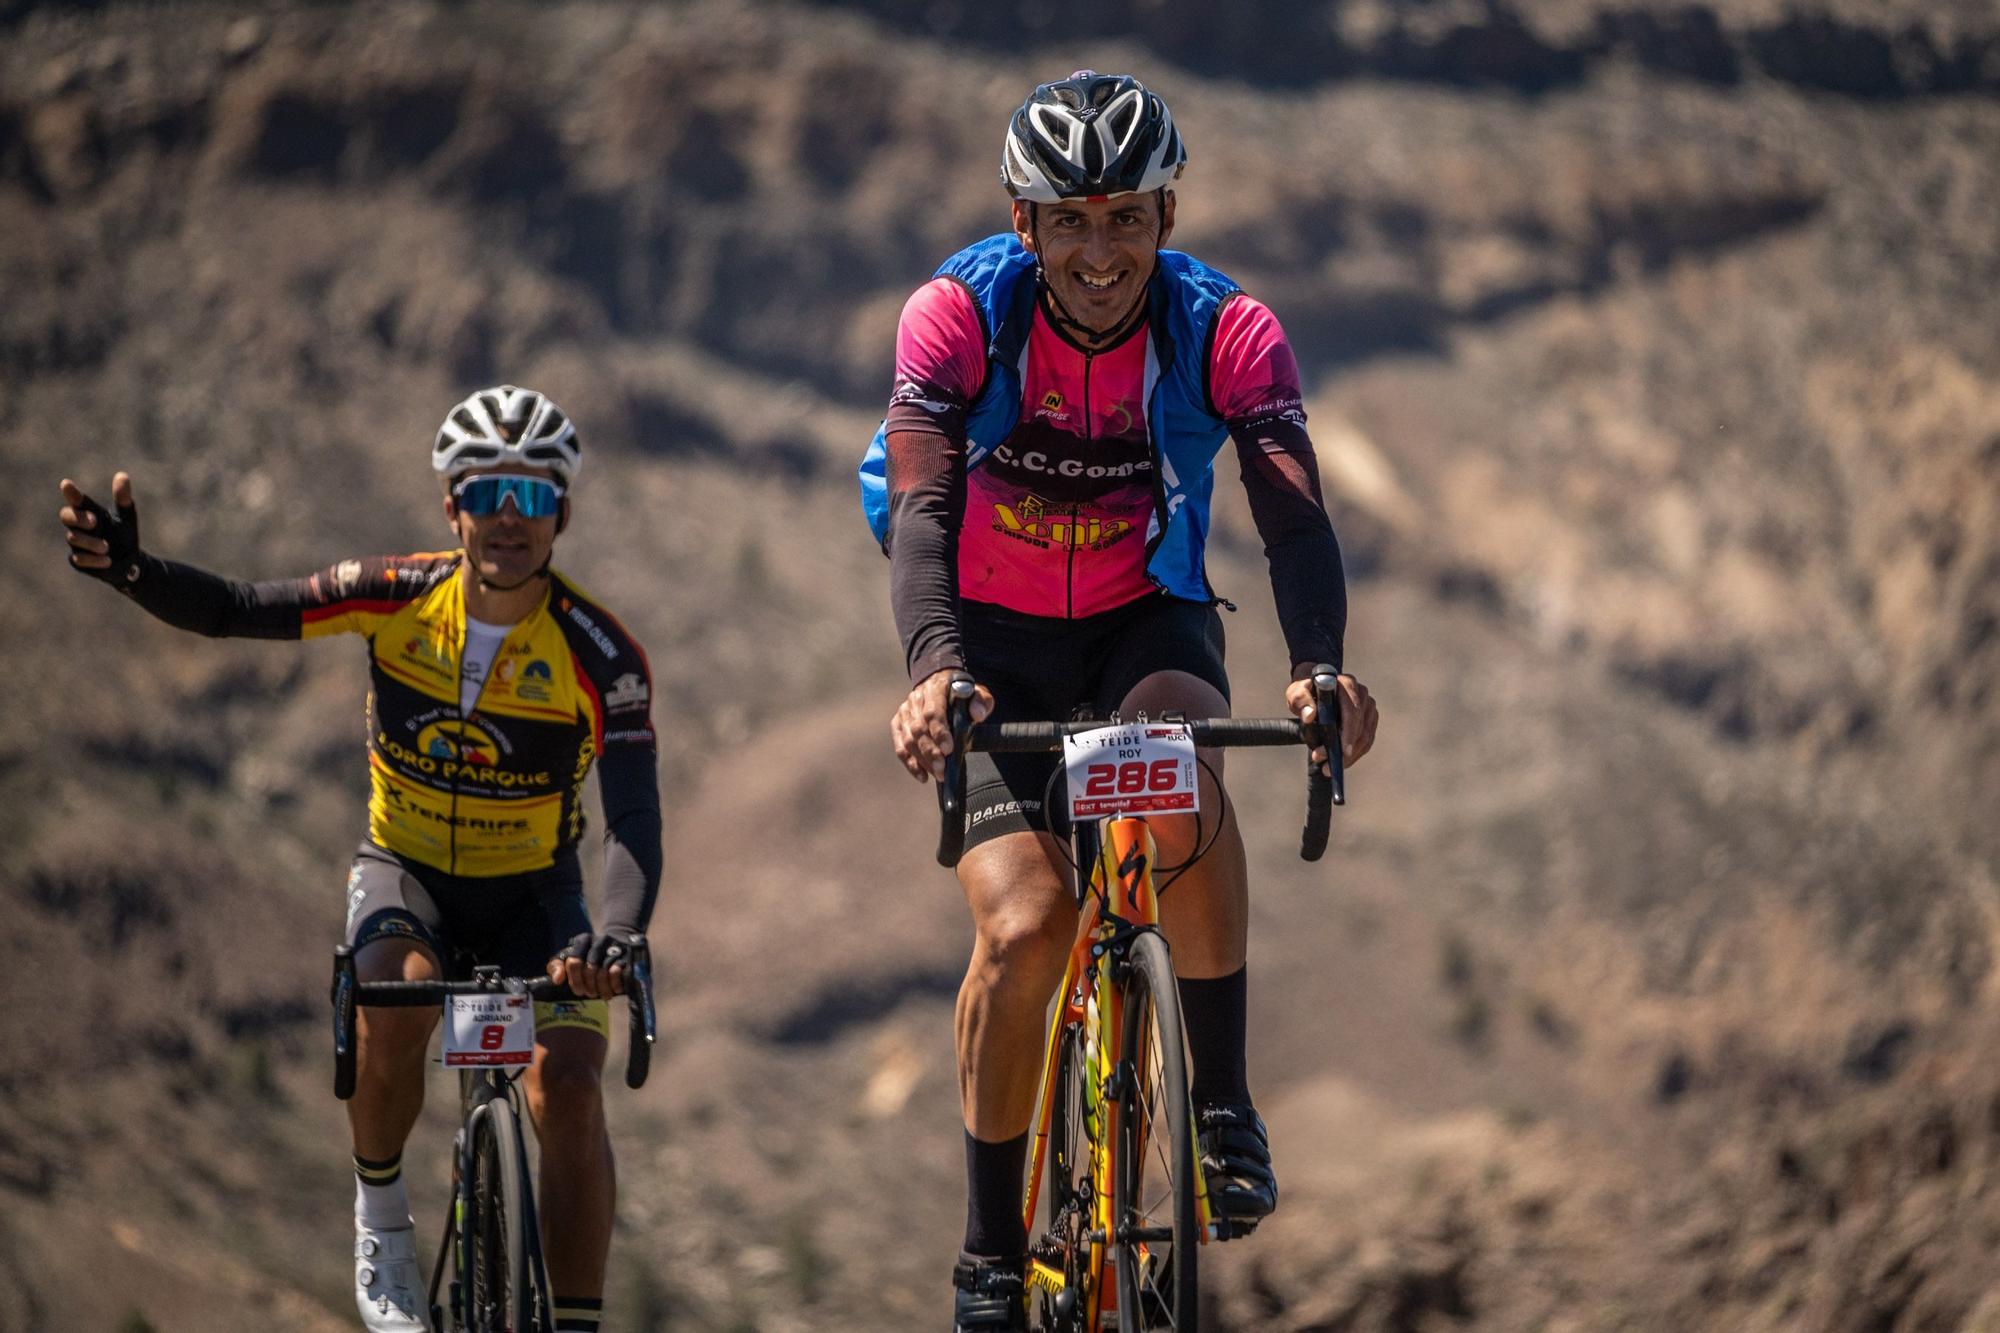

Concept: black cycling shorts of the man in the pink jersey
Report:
left=958, top=594, right=1230, bottom=847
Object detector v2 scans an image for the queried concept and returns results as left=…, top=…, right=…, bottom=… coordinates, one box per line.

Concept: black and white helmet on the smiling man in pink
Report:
left=1000, top=70, right=1188, bottom=204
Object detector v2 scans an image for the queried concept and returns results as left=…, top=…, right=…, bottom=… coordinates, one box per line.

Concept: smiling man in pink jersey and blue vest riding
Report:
left=862, top=70, right=1378, bottom=1333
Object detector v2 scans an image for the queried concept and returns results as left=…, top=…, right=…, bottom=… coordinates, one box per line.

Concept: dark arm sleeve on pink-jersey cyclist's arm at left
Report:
left=888, top=422, right=966, bottom=685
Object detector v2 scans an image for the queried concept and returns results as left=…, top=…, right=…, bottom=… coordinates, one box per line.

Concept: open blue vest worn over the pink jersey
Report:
left=860, top=232, right=1240, bottom=602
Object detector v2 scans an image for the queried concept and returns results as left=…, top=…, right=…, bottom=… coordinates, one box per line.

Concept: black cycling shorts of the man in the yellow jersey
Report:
left=348, top=841, right=610, bottom=1037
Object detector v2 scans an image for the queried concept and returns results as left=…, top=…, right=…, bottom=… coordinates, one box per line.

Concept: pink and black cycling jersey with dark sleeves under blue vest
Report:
left=886, top=278, right=1344, bottom=679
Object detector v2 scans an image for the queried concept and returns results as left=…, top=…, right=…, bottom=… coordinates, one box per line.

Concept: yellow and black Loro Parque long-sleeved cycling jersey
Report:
left=128, top=550, right=660, bottom=896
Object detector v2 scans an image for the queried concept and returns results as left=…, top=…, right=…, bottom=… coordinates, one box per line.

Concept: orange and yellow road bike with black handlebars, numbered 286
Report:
left=938, top=673, right=1344, bottom=1333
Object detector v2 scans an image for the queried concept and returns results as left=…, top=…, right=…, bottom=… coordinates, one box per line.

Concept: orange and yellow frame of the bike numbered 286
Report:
left=1022, top=815, right=1214, bottom=1329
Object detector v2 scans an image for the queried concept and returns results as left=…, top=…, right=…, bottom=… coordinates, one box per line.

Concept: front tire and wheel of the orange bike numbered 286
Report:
left=1112, top=931, right=1200, bottom=1333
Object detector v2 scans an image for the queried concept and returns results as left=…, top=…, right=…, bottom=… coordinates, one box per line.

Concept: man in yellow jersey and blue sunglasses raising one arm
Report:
left=60, top=384, right=660, bottom=1333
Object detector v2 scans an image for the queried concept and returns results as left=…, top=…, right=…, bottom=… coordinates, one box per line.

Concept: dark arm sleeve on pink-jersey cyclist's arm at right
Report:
left=1230, top=418, right=1348, bottom=675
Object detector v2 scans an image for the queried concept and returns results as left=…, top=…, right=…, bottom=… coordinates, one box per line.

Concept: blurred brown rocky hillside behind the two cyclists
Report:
left=0, top=0, right=2000, bottom=1333
